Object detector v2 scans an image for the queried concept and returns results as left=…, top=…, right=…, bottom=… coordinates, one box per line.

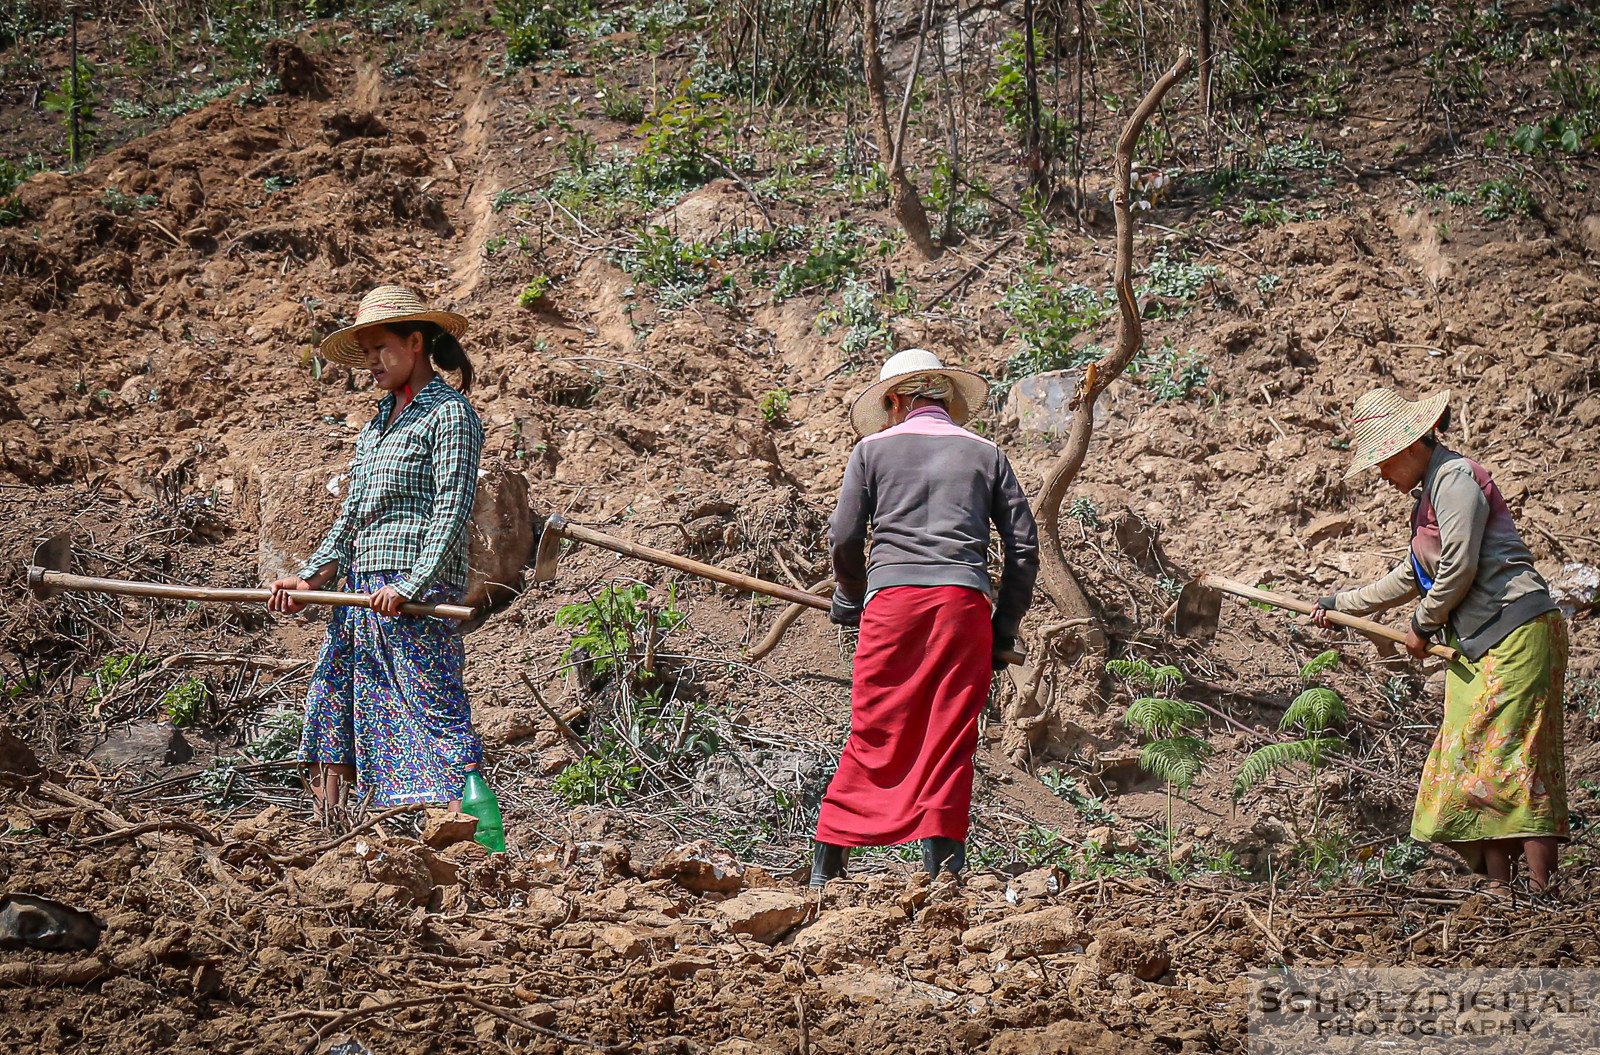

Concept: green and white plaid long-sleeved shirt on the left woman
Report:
left=301, top=376, right=483, bottom=599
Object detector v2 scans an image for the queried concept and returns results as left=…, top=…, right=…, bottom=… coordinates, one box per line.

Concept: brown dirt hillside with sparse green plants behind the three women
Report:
left=0, top=3, right=1600, bottom=1055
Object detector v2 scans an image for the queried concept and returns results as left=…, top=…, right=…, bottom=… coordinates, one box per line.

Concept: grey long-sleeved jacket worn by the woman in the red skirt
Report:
left=829, top=407, right=1038, bottom=637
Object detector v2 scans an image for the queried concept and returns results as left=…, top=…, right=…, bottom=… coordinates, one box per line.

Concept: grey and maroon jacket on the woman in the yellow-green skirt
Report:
left=1323, top=447, right=1555, bottom=660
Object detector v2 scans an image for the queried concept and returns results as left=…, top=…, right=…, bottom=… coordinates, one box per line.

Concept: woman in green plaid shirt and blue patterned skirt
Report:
left=269, top=287, right=483, bottom=816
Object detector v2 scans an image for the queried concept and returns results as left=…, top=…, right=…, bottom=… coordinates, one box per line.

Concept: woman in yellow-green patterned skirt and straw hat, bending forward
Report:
left=1314, top=389, right=1568, bottom=890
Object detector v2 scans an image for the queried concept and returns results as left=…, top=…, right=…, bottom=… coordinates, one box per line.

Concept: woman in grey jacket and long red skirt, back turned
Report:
left=811, top=349, right=1038, bottom=887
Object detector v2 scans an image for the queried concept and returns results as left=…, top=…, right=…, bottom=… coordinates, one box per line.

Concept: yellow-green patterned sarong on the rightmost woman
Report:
left=1411, top=612, right=1566, bottom=872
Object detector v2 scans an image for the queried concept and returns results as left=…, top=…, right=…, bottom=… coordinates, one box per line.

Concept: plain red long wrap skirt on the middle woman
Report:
left=816, top=586, right=994, bottom=847
